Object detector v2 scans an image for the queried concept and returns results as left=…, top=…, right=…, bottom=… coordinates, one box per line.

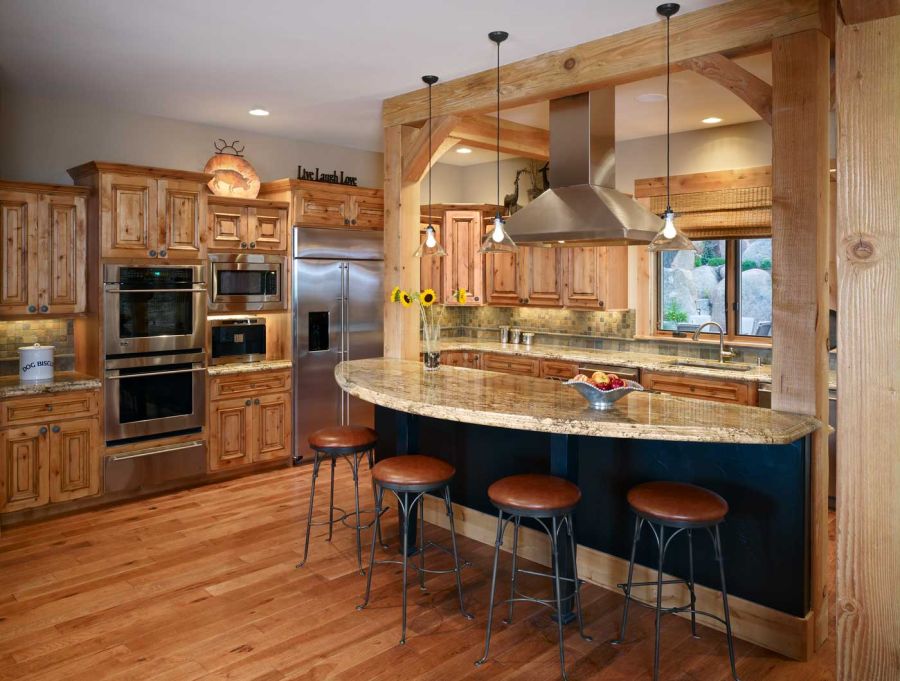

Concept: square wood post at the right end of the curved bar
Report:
left=772, top=30, right=830, bottom=652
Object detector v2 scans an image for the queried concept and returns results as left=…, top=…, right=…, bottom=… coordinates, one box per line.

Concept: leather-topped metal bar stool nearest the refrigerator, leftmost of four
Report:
left=297, top=426, right=381, bottom=574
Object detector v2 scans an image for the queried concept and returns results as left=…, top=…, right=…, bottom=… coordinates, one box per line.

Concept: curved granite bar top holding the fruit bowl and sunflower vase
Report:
left=334, top=357, right=820, bottom=444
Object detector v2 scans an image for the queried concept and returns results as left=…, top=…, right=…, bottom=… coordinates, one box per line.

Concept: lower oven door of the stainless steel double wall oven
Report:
left=104, top=352, right=206, bottom=443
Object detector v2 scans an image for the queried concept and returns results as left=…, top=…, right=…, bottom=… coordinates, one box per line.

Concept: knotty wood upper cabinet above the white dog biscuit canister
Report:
left=0, top=182, right=89, bottom=317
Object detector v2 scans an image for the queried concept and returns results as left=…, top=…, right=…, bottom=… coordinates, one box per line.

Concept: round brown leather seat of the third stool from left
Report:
left=488, top=474, right=581, bottom=516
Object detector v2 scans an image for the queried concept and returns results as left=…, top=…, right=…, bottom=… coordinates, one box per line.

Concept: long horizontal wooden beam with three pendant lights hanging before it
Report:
left=382, top=0, right=823, bottom=127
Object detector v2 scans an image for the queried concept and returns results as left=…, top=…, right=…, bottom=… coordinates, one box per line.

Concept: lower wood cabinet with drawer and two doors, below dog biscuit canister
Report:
left=0, top=391, right=101, bottom=512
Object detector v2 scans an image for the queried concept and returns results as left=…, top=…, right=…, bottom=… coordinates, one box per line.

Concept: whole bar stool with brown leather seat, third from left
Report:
left=475, top=474, right=592, bottom=680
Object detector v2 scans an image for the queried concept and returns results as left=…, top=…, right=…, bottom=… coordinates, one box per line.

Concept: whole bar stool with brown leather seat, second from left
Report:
left=356, top=454, right=472, bottom=645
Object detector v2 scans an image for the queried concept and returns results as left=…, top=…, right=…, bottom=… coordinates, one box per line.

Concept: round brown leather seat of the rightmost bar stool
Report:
left=628, top=482, right=728, bottom=525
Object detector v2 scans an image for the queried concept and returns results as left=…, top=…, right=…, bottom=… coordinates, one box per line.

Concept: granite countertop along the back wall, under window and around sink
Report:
left=441, top=338, right=837, bottom=390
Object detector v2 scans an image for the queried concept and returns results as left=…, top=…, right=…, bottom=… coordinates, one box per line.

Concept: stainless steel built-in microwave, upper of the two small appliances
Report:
left=209, top=253, right=287, bottom=312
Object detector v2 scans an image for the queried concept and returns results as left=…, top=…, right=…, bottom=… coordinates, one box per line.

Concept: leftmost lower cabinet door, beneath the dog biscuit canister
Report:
left=0, top=426, right=50, bottom=511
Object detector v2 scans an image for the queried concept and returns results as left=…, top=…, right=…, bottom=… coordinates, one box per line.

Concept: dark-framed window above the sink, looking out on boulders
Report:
left=657, top=239, right=772, bottom=340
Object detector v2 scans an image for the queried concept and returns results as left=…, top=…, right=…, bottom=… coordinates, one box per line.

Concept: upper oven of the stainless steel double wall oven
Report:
left=103, top=265, right=207, bottom=356
